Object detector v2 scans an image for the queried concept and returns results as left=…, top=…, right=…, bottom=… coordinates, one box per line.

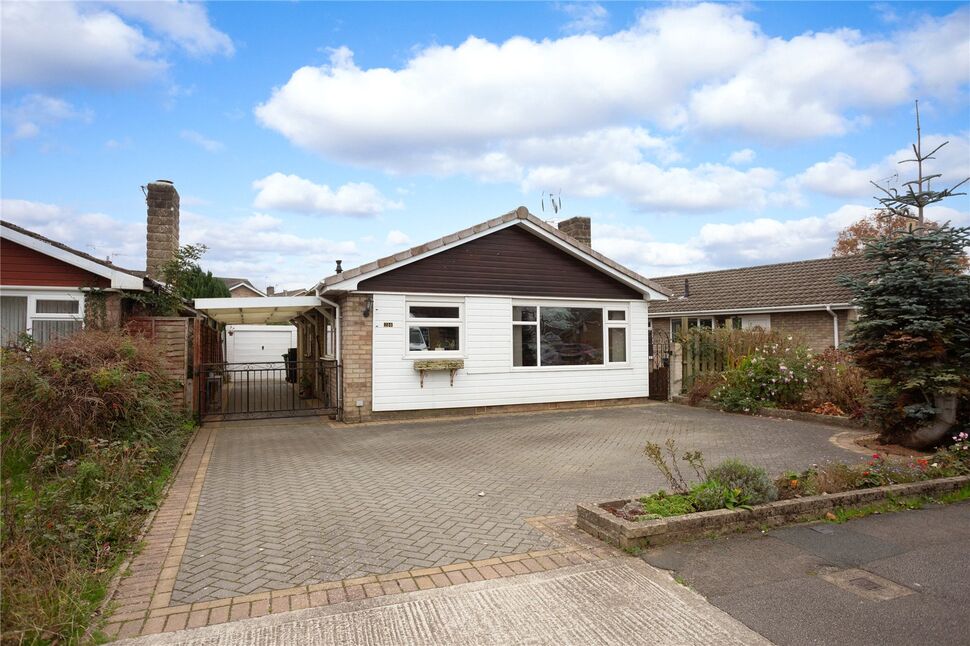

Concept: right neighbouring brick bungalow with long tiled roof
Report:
left=650, top=255, right=869, bottom=350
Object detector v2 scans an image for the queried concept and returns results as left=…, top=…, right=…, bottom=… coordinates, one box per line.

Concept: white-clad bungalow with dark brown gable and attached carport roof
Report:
left=195, top=207, right=667, bottom=422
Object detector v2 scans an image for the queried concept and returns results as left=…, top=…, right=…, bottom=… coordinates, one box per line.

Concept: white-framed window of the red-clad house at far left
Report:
left=0, top=288, right=84, bottom=346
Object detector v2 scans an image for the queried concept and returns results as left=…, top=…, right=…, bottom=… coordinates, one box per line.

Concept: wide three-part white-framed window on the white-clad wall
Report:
left=512, top=301, right=630, bottom=369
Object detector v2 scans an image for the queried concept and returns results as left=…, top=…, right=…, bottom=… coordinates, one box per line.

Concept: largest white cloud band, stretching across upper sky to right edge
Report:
left=256, top=4, right=967, bottom=166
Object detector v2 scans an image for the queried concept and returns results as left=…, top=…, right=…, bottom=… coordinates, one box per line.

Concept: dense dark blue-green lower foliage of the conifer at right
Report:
left=846, top=226, right=970, bottom=446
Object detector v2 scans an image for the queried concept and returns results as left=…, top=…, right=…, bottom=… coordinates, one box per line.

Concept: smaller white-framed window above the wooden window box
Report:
left=405, top=299, right=465, bottom=358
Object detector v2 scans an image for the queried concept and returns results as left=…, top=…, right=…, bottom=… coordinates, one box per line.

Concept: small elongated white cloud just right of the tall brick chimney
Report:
left=253, top=173, right=403, bottom=216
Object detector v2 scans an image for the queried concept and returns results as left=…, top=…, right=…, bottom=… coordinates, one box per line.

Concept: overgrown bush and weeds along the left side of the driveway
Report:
left=0, top=330, right=191, bottom=643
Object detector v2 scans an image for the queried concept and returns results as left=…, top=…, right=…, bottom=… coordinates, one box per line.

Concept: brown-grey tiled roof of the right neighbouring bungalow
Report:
left=650, top=255, right=871, bottom=316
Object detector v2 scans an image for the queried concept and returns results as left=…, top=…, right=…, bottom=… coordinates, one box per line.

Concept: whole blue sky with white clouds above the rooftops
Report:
left=0, top=0, right=970, bottom=289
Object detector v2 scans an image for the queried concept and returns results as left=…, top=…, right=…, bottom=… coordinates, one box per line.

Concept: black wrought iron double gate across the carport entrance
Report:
left=197, top=360, right=341, bottom=419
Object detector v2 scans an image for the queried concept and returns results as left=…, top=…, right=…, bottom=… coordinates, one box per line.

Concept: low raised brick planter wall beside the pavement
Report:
left=576, top=476, right=970, bottom=548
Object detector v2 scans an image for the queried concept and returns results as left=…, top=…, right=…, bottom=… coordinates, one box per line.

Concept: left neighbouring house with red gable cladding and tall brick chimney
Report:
left=0, top=180, right=222, bottom=406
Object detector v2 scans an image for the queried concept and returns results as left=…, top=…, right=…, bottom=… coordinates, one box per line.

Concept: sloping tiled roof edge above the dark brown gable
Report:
left=321, top=206, right=669, bottom=294
